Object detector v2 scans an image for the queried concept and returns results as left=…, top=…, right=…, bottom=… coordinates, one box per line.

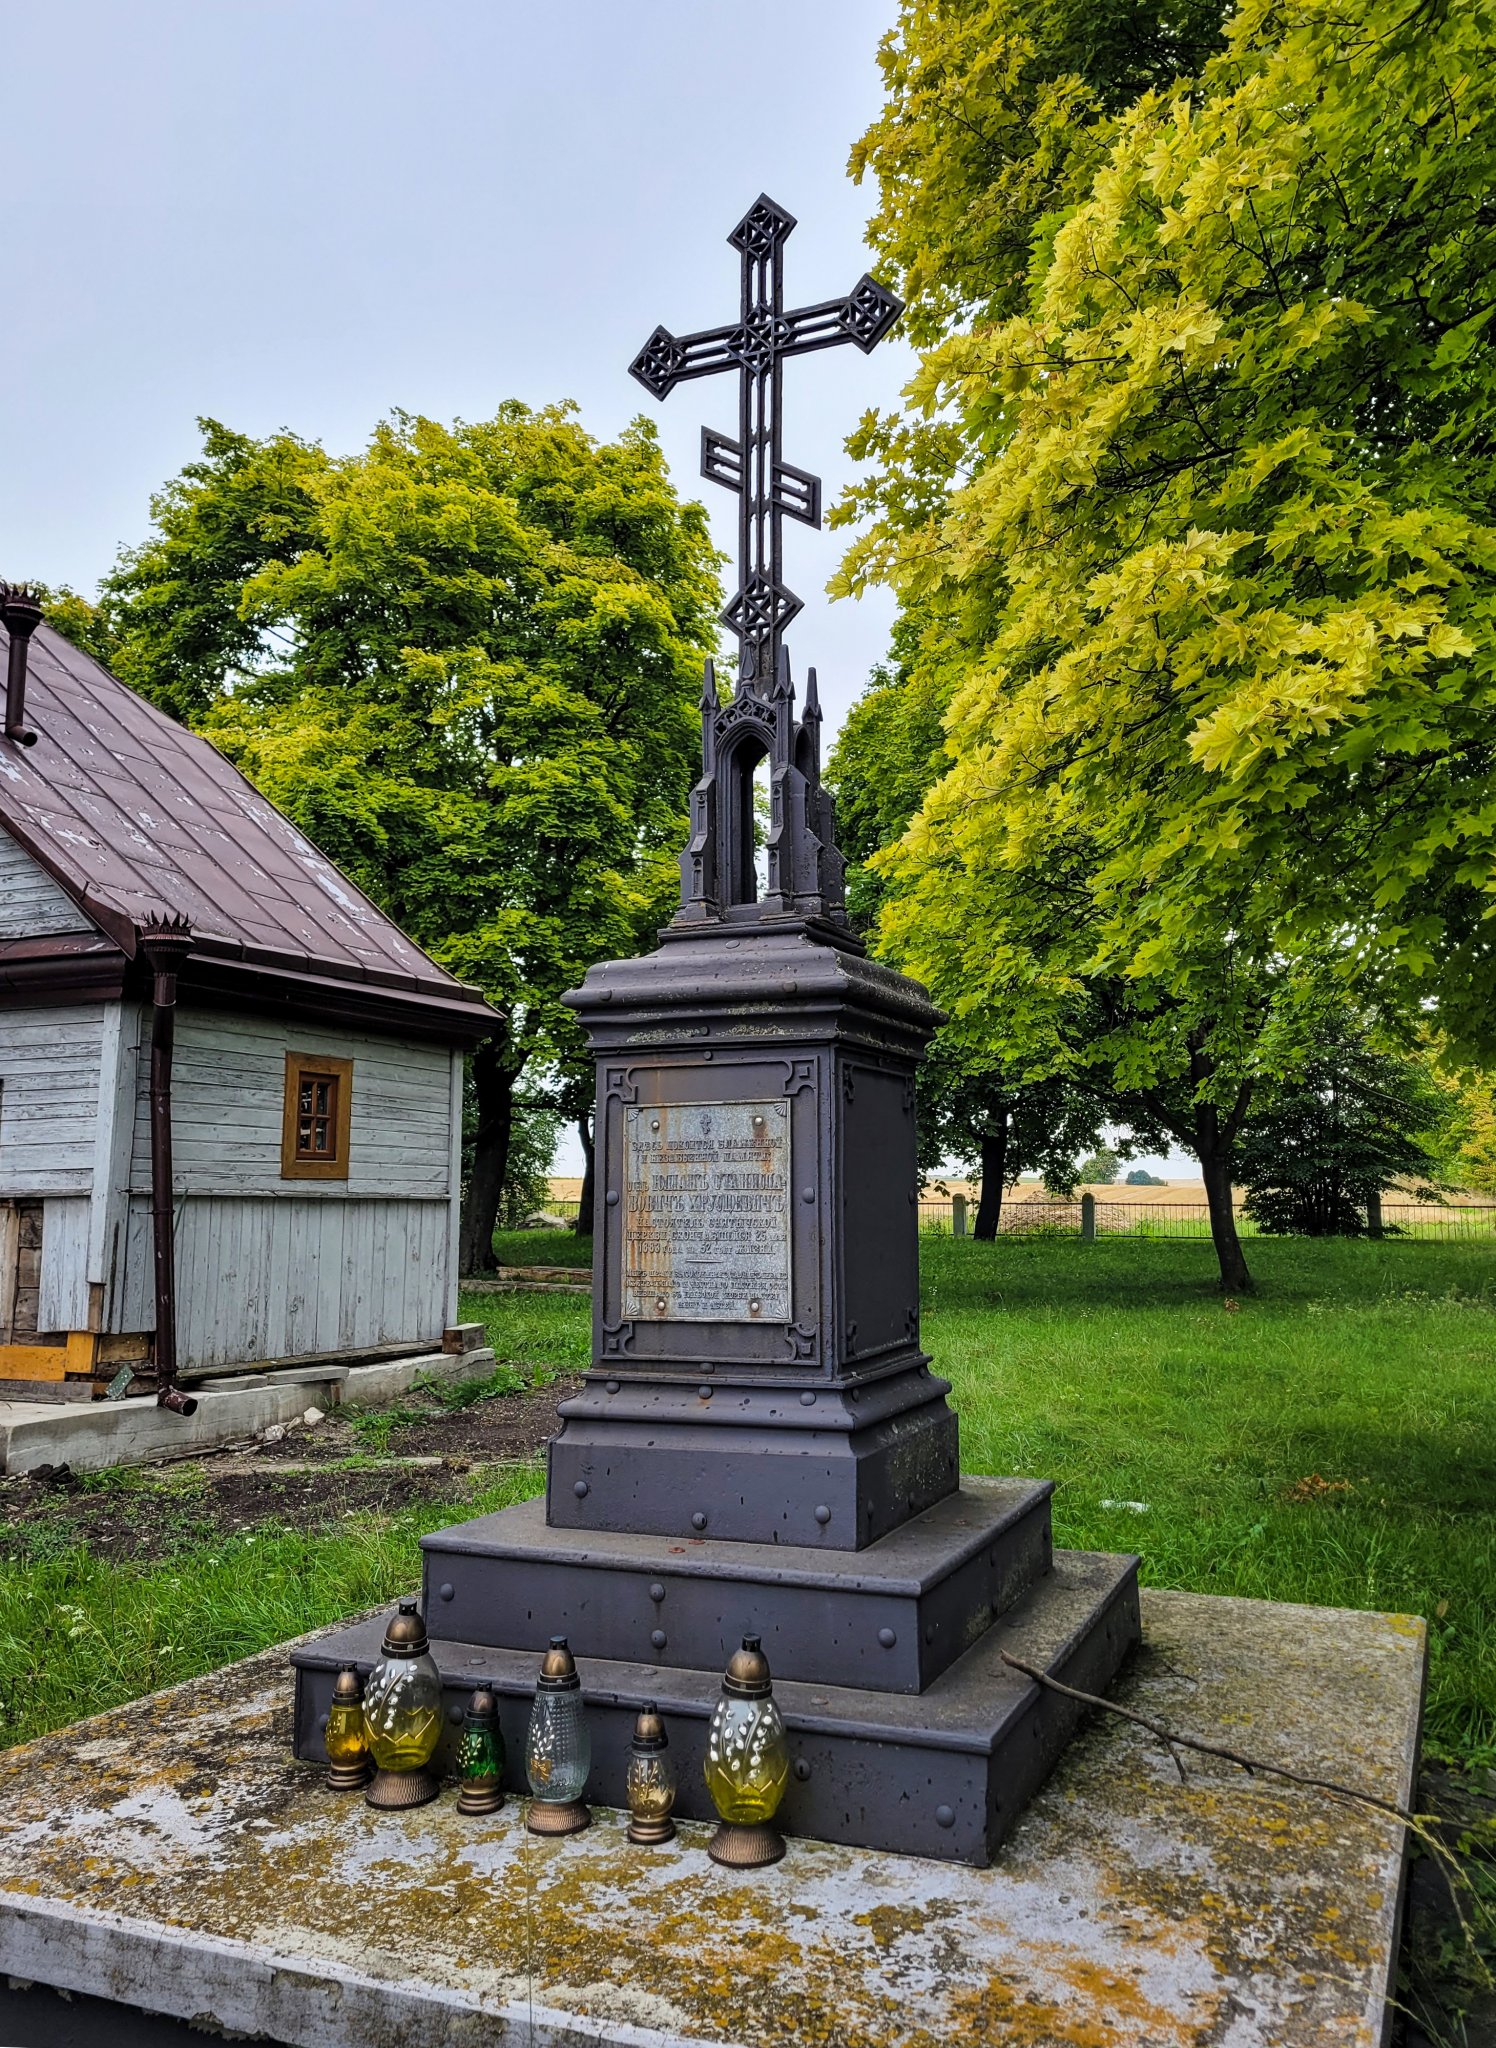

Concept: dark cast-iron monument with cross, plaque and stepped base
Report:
left=295, top=199, right=1137, bottom=1862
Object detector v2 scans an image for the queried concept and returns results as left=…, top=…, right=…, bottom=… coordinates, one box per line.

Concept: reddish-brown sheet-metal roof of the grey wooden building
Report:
left=0, top=625, right=498, bottom=1030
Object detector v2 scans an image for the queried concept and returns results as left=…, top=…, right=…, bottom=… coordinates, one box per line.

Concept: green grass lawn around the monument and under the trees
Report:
left=0, top=1233, right=1496, bottom=1763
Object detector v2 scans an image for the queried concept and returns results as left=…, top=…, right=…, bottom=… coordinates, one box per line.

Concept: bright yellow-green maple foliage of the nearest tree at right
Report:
left=844, top=0, right=1496, bottom=1047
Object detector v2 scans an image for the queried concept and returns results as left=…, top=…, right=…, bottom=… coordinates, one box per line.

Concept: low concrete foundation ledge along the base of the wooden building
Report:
left=0, top=1350, right=494, bottom=1473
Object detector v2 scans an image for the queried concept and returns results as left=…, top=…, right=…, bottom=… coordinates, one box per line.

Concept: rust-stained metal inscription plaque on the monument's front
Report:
left=623, top=1102, right=793, bottom=1323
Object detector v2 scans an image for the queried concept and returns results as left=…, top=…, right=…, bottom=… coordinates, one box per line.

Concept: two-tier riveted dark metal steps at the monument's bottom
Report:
left=291, top=1479, right=1137, bottom=1864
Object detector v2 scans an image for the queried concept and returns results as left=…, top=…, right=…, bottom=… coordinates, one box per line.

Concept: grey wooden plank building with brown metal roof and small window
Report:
left=0, top=592, right=502, bottom=1397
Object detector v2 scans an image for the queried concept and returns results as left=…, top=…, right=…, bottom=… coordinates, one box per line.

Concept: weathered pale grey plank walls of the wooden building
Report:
left=0, top=1004, right=461, bottom=1366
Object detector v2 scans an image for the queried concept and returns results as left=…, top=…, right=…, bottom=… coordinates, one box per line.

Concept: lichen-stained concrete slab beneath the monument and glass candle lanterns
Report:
left=0, top=1591, right=1424, bottom=2048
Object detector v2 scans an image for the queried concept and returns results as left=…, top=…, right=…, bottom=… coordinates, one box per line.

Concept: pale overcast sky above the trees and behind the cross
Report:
left=0, top=0, right=912, bottom=725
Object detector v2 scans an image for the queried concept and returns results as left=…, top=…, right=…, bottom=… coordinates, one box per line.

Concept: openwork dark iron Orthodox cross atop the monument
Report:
left=629, top=195, right=904, bottom=684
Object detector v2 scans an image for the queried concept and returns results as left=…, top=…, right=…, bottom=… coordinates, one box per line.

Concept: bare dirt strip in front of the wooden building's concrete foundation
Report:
left=0, top=1380, right=580, bottom=1563
